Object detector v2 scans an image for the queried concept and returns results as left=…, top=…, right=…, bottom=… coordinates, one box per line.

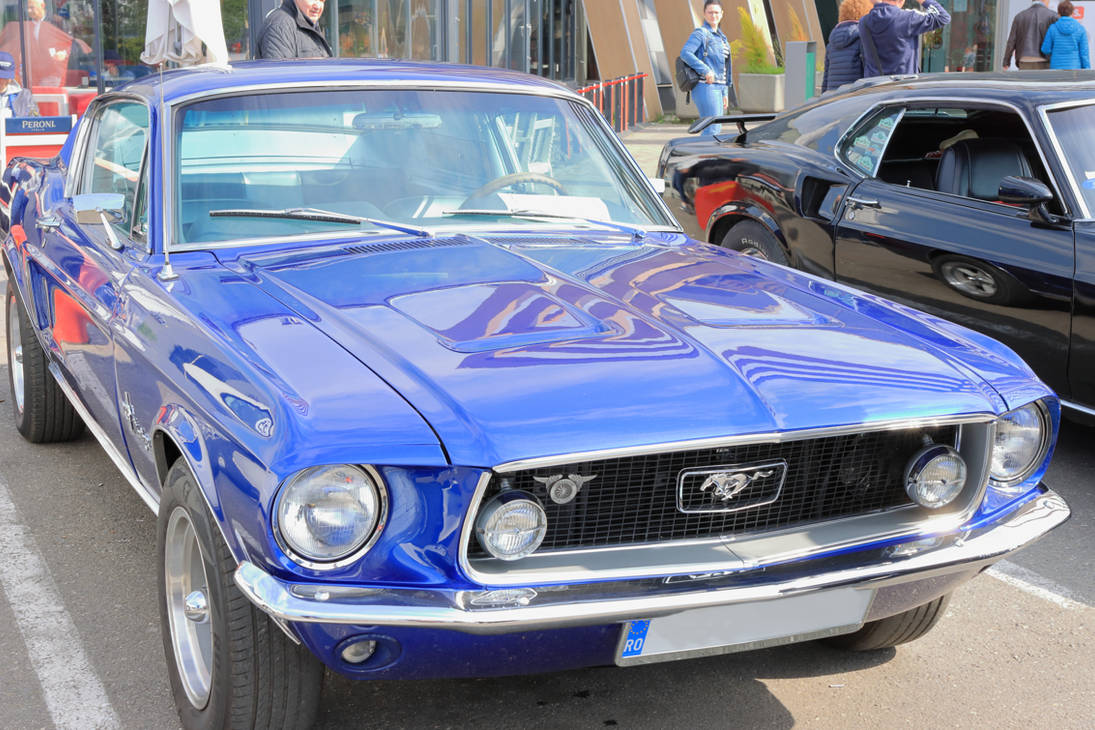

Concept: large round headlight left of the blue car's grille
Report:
left=275, top=464, right=385, bottom=567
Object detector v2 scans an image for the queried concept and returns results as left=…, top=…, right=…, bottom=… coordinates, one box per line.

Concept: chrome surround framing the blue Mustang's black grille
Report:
left=458, top=413, right=996, bottom=586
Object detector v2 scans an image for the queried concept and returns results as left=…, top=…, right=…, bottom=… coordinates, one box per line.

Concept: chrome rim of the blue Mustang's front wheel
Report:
left=163, top=507, right=212, bottom=709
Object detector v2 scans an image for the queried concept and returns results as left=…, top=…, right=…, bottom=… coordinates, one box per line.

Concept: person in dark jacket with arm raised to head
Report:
left=860, top=0, right=950, bottom=77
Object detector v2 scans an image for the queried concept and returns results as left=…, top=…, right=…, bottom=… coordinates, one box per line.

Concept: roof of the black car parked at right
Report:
left=817, top=70, right=1095, bottom=108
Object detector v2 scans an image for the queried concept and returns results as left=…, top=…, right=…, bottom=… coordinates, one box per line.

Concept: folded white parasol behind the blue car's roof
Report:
left=140, top=0, right=228, bottom=66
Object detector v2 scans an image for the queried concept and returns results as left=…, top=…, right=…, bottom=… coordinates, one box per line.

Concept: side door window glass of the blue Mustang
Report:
left=80, top=102, right=148, bottom=234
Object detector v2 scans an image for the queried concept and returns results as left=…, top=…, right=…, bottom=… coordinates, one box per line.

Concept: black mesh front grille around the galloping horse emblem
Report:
left=469, top=426, right=957, bottom=557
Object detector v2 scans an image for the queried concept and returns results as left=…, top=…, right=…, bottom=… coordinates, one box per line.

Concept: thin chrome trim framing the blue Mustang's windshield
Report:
left=158, top=79, right=683, bottom=253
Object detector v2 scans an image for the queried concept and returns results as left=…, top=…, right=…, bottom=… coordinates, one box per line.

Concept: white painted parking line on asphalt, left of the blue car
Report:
left=0, top=470, right=120, bottom=728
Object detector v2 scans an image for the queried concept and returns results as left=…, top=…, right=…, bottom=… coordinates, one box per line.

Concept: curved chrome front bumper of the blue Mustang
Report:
left=235, top=490, right=1070, bottom=634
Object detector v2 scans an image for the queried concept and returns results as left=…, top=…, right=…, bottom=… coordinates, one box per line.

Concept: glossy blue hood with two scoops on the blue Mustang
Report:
left=226, top=234, right=1030, bottom=465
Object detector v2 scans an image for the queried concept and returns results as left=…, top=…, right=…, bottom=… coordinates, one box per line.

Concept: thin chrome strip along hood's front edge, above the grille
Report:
left=494, top=414, right=996, bottom=474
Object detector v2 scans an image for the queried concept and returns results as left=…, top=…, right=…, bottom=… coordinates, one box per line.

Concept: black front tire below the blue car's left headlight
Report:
left=157, top=460, right=323, bottom=730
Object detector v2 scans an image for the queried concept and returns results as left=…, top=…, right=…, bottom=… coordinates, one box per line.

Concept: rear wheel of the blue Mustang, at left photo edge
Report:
left=4, top=279, right=83, bottom=443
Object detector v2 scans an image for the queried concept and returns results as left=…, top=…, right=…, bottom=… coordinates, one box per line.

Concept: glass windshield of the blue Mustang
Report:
left=175, top=90, right=675, bottom=246
